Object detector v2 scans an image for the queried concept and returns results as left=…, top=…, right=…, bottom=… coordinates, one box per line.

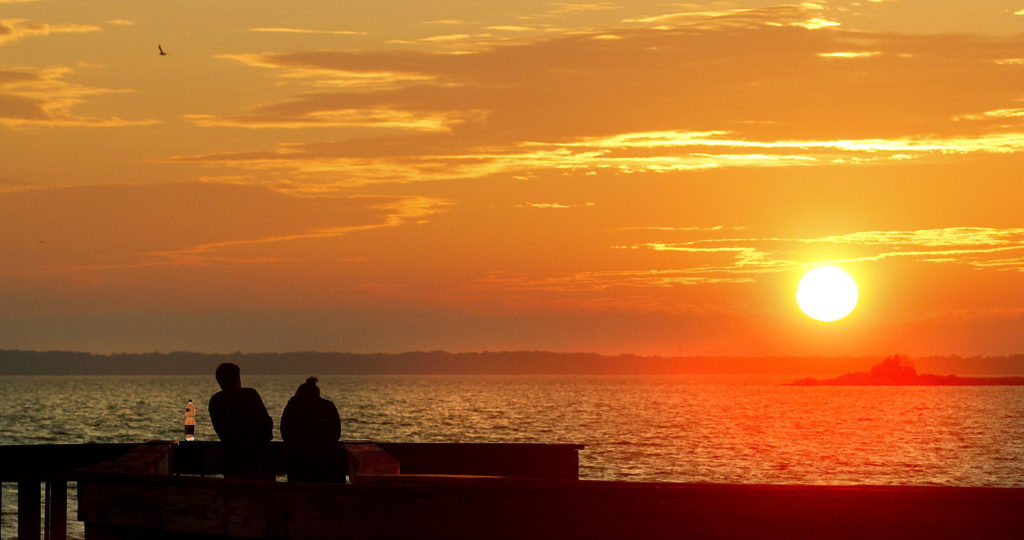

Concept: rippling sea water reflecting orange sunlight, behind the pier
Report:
left=0, top=374, right=1024, bottom=538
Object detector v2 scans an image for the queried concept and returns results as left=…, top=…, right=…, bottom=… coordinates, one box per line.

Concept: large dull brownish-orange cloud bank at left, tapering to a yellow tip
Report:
left=0, top=182, right=449, bottom=278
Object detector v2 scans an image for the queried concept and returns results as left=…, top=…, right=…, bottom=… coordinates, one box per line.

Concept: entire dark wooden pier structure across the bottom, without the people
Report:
left=0, top=442, right=1024, bottom=540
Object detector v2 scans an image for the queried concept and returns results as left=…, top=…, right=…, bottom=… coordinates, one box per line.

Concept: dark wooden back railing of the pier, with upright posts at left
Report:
left=0, top=442, right=583, bottom=540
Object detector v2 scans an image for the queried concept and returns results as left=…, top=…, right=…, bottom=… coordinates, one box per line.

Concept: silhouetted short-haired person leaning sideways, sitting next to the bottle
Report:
left=209, top=363, right=274, bottom=481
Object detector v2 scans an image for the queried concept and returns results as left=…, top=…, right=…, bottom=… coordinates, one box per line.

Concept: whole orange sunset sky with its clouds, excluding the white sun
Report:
left=6, top=0, right=1024, bottom=356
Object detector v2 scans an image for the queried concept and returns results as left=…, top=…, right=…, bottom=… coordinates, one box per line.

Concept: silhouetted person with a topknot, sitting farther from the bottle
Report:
left=281, top=377, right=345, bottom=482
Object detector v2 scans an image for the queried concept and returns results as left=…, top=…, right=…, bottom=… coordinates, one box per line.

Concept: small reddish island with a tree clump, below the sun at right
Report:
left=790, top=355, right=1024, bottom=386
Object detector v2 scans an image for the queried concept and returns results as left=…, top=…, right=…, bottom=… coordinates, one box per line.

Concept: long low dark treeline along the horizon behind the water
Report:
left=0, top=349, right=1024, bottom=376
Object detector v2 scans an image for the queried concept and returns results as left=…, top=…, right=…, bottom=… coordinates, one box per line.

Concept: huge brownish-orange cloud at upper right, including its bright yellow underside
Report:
left=171, top=4, right=1024, bottom=184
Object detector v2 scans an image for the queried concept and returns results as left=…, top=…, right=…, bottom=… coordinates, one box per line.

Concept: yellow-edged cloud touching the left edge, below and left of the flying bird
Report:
left=0, top=66, right=159, bottom=128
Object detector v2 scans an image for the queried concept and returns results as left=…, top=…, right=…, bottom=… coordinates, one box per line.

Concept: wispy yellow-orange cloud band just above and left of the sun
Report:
left=434, top=225, right=1024, bottom=309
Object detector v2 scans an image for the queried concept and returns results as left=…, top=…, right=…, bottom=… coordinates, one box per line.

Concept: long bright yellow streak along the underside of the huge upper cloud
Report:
left=170, top=126, right=1024, bottom=185
